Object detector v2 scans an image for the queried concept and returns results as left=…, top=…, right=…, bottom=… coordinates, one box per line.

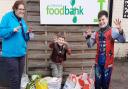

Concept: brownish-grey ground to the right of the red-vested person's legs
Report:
left=110, top=60, right=128, bottom=89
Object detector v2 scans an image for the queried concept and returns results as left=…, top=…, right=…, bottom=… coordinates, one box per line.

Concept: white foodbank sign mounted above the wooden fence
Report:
left=40, top=0, right=109, bottom=25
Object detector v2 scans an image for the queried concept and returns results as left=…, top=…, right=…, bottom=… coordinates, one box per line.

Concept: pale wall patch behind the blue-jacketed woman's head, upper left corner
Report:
left=0, top=0, right=16, bottom=20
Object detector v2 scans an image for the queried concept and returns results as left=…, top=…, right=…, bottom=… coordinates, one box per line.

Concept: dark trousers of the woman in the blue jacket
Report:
left=3, top=56, right=25, bottom=89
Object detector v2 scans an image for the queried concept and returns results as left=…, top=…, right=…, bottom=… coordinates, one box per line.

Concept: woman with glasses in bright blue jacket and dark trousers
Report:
left=0, top=0, right=29, bottom=89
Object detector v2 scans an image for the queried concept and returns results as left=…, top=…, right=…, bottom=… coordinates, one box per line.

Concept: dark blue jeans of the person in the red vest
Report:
left=95, top=65, right=112, bottom=89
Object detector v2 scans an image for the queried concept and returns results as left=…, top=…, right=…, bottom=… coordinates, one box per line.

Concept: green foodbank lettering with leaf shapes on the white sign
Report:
left=46, top=0, right=84, bottom=23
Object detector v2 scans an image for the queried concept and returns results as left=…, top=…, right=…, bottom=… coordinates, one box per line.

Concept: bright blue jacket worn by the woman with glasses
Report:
left=0, top=11, right=29, bottom=57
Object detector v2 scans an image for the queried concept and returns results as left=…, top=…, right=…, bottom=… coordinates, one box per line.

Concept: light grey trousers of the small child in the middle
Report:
left=50, top=62, right=63, bottom=77
